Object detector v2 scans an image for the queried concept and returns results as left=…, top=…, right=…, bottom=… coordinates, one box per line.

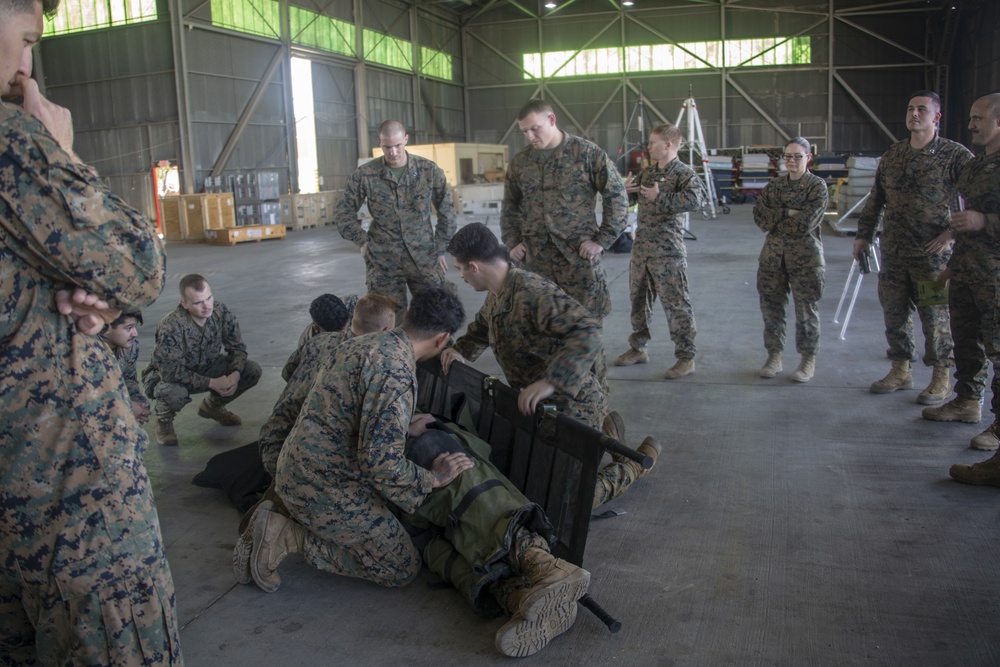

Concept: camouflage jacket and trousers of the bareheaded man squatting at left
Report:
left=142, top=301, right=261, bottom=421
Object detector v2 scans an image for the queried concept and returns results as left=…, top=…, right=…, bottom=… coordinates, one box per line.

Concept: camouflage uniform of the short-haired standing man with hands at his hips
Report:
left=334, top=158, right=456, bottom=323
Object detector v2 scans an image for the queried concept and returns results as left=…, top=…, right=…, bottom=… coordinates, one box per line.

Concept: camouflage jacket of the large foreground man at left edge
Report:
left=0, top=103, right=165, bottom=580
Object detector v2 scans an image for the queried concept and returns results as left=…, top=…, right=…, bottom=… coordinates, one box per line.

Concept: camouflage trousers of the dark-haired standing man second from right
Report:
left=878, top=253, right=953, bottom=366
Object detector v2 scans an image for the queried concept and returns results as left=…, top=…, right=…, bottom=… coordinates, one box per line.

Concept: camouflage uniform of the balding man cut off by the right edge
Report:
left=948, top=152, right=1000, bottom=415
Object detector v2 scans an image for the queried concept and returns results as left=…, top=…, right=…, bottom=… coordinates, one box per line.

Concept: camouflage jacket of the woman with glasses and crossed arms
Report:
left=753, top=172, right=829, bottom=268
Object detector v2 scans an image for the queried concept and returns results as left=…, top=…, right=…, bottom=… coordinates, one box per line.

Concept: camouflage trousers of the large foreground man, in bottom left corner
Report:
left=0, top=531, right=183, bottom=666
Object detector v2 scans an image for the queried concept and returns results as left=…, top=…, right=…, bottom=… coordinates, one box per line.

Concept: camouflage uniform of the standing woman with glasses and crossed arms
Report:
left=753, top=171, right=829, bottom=355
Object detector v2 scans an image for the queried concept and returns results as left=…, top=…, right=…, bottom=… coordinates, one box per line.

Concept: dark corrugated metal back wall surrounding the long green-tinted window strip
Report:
left=466, top=0, right=948, bottom=160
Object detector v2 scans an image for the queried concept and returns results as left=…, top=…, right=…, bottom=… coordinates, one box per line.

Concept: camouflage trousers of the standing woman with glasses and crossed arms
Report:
left=757, top=260, right=826, bottom=355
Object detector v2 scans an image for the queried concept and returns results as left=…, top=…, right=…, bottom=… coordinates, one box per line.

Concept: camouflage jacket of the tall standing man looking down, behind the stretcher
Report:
left=500, top=133, right=628, bottom=262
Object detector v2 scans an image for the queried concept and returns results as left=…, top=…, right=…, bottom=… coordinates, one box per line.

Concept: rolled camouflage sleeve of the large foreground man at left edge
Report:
left=0, top=104, right=166, bottom=311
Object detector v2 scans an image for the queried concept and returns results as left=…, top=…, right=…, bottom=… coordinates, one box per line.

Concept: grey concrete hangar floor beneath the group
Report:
left=140, top=206, right=1000, bottom=666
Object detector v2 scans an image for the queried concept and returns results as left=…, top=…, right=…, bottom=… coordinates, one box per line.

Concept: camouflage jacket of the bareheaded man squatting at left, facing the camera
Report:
left=142, top=301, right=247, bottom=392
